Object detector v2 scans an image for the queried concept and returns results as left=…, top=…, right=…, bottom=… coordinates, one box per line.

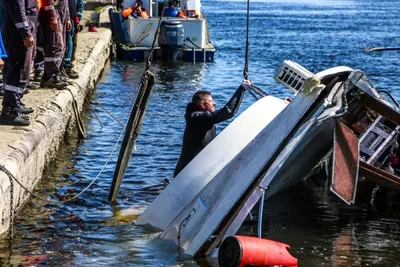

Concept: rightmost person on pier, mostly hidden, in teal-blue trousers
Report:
left=63, top=0, right=83, bottom=79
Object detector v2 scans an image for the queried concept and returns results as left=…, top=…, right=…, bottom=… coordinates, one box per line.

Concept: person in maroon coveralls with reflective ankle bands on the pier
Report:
left=39, top=0, right=73, bottom=89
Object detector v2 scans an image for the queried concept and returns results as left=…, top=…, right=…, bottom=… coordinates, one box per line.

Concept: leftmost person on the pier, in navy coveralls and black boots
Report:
left=0, top=0, right=38, bottom=126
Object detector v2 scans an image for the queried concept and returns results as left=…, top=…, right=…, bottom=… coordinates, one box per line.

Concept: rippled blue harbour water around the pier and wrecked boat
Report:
left=0, top=0, right=400, bottom=267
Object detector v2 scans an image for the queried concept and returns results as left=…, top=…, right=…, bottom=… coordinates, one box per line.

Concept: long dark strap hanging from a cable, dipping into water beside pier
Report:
left=108, top=1, right=168, bottom=202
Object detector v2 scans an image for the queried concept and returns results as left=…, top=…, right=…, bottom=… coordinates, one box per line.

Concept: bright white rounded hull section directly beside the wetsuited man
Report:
left=135, top=96, right=286, bottom=230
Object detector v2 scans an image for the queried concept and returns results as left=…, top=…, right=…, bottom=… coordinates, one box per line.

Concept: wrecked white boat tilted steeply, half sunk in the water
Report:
left=136, top=61, right=400, bottom=256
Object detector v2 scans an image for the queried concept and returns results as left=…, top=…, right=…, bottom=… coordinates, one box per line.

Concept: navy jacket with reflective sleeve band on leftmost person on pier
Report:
left=0, top=0, right=38, bottom=39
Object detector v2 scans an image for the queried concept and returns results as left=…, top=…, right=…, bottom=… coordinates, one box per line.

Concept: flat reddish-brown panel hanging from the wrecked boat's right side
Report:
left=330, top=120, right=360, bottom=205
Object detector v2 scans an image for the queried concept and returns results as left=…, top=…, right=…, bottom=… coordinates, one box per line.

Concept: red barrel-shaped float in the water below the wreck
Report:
left=218, top=236, right=298, bottom=267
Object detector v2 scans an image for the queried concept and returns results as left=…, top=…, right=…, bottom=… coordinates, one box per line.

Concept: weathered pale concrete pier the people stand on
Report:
left=0, top=28, right=111, bottom=236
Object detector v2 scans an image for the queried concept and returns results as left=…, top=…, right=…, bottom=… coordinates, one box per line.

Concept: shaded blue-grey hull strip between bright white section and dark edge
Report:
left=158, top=85, right=322, bottom=256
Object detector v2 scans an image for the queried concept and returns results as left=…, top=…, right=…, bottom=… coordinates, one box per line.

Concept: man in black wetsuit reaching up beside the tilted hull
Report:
left=174, top=86, right=246, bottom=177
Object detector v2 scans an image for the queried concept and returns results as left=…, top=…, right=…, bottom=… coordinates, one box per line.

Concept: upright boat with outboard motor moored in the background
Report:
left=109, top=0, right=215, bottom=62
